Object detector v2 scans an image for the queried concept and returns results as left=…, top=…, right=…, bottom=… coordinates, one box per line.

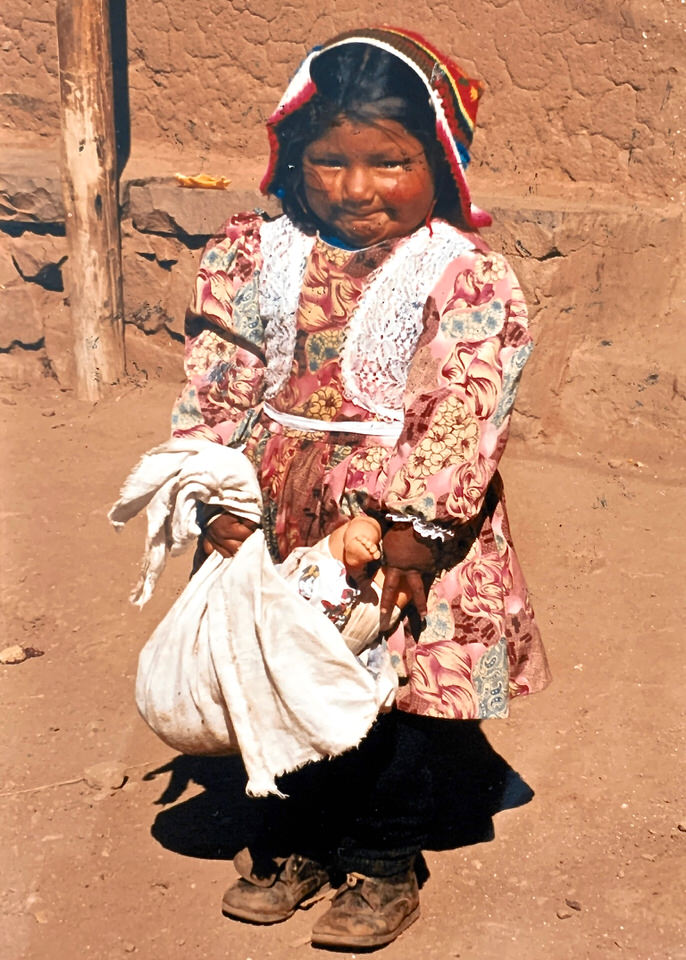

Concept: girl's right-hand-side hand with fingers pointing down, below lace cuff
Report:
left=379, top=523, right=435, bottom=631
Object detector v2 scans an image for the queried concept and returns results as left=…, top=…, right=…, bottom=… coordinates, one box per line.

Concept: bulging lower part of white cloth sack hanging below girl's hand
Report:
left=136, top=530, right=397, bottom=796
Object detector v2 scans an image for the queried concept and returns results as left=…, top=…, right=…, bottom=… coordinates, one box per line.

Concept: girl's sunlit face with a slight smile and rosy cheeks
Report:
left=303, top=117, right=434, bottom=247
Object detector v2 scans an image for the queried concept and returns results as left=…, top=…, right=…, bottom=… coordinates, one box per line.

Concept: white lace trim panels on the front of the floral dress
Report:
left=259, top=217, right=472, bottom=421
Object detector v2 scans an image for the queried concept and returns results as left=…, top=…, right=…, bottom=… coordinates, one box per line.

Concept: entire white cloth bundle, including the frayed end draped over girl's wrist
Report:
left=110, top=441, right=397, bottom=796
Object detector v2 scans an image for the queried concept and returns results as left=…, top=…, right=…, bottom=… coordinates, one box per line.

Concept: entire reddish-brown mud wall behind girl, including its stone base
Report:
left=0, top=0, right=686, bottom=460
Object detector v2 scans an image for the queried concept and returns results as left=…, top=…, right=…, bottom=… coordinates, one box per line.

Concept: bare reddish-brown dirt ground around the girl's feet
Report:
left=0, top=380, right=686, bottom=960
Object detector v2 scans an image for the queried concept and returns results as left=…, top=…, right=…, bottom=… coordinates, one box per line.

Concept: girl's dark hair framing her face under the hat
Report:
left=271, top=42, right=465, bottom=233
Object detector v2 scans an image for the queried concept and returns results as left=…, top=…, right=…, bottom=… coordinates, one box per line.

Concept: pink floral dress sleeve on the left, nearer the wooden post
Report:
left=172, top=214, right=264, bottom=443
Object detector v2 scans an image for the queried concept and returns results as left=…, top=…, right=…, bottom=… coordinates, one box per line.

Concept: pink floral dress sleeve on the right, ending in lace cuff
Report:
left=381, top=250, right=532, bottom=527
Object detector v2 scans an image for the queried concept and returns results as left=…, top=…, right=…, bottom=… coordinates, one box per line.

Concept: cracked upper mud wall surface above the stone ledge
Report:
left=0, top=0, right=686, bottom=199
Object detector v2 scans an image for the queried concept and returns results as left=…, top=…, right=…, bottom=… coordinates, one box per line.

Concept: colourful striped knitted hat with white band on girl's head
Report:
left=260, top=27, right=491, bottom=227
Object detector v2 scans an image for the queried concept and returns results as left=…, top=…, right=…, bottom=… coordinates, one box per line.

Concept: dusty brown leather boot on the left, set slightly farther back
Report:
left=222, top=849, right=329, bottom=923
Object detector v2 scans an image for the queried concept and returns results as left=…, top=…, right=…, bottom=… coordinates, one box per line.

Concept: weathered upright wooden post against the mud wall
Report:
left=57, top=0, right=125, bottom=400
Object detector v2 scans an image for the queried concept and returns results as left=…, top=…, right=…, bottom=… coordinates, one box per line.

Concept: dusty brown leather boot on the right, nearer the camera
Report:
left=312, top=869, right=419, bottom=949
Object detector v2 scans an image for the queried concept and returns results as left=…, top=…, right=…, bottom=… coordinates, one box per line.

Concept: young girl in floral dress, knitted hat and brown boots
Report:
left=174, top=28, right=548, bottom=949
